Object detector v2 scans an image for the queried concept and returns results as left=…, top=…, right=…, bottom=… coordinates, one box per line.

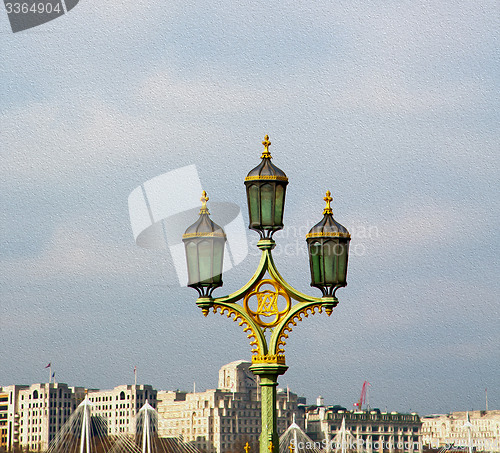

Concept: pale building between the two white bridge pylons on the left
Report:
left=88, top=385, right=157, bottom=435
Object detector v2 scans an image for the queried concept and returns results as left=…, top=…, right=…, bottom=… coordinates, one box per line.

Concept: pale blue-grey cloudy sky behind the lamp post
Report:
left=0, top=0, right=500, bottom=414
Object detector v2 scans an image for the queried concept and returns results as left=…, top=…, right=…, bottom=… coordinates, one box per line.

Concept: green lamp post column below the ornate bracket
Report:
left=250, top=363, right=288, bottom=453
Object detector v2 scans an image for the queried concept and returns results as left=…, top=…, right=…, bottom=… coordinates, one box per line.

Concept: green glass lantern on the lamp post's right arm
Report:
left=306, top=191, right=351, bottom=297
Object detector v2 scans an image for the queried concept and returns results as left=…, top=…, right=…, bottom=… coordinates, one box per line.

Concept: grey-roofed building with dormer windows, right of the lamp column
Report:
left=305, top=397, right=422, bottom=453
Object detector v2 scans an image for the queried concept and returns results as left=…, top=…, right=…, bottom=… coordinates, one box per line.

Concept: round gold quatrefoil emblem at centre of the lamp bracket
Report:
left=243, top=279, right=292, bottom=328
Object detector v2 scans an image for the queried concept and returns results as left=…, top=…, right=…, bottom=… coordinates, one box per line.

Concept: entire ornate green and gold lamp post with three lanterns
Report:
left=182, top=135, right=350, bottom=453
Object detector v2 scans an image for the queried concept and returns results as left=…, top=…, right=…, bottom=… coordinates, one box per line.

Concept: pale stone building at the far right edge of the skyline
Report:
left=422, top=411, right=500, bottom=452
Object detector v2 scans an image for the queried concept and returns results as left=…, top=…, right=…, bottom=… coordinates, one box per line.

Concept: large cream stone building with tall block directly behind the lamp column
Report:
left=157, top=360, right=303, bottom=453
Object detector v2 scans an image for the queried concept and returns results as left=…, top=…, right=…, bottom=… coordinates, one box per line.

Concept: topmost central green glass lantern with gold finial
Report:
left=245, top=135, right=288, bottom=239
